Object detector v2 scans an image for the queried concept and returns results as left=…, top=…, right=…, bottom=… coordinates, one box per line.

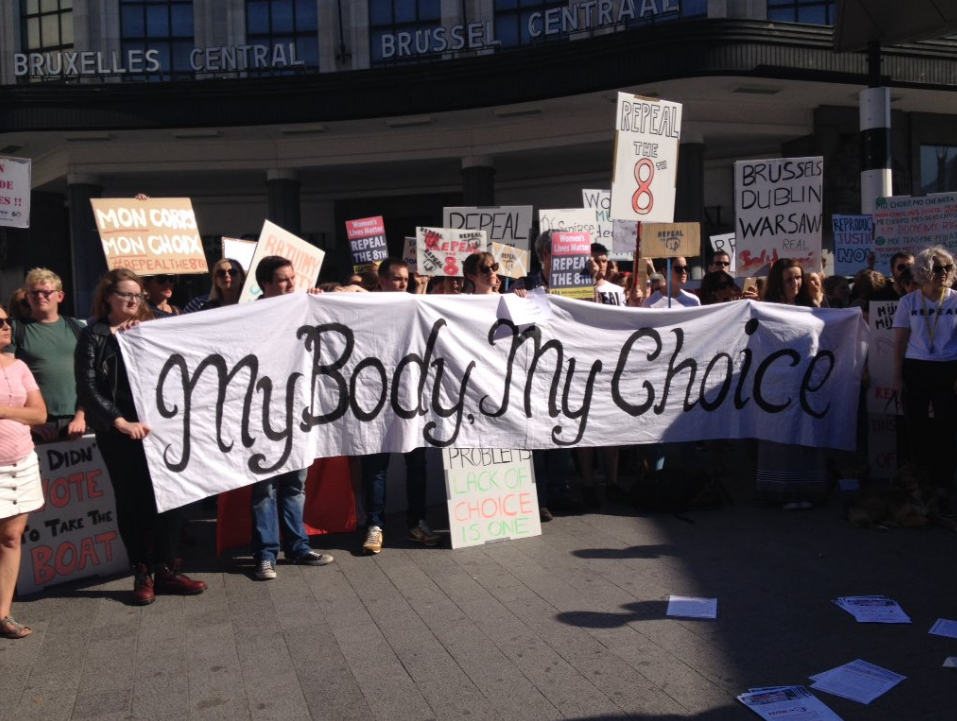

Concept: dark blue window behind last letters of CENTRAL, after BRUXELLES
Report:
left=246, top=0, right=319, bottom=75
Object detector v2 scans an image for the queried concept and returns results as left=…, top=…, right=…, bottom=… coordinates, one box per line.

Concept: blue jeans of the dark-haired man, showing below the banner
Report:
left=251, top=468, right=311, bottom=563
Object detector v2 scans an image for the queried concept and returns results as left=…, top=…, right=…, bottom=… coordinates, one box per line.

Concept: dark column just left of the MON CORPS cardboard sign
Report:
left=67, top=173, right=106, bottom=318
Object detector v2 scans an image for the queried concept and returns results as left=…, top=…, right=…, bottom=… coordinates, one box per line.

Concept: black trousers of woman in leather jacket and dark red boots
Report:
left=96, top=430, right=182, bottom=571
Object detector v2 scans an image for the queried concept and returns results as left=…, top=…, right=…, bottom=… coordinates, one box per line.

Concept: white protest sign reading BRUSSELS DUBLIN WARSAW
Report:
left=734, top=157, right=824, bottom=276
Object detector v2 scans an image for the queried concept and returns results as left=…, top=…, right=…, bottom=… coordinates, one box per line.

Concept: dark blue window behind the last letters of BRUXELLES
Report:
left=120, top=0, right=194, bottom=81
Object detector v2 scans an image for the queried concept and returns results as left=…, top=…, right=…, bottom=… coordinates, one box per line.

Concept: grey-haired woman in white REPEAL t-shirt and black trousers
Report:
left=894, top=246, right=957, bottom=513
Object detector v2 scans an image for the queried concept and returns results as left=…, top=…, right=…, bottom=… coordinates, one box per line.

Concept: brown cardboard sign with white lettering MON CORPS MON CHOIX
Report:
left=90, top=198, right=209, bottom=275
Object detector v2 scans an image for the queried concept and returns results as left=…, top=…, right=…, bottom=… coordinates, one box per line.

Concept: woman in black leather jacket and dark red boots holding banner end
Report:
left=74, top=268, right=206, bottom=606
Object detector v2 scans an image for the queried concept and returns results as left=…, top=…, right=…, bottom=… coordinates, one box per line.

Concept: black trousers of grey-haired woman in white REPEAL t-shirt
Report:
left=903, top=358, right=957, bottom=492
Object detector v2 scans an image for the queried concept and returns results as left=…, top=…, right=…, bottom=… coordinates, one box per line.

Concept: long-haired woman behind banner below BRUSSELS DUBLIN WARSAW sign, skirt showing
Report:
left=755, top=258, right=827, bottom=511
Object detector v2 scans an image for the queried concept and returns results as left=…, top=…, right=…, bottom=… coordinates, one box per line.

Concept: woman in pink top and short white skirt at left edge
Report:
left=0, top=307, right=47, bottom=638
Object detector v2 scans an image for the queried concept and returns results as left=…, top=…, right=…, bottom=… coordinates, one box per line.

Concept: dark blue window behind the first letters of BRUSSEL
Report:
left=369, top=0, right=440, bottom=65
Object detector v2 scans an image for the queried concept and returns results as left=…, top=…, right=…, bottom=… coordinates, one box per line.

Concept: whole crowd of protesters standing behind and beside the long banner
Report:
left=0, top=231, right=957, bottom=638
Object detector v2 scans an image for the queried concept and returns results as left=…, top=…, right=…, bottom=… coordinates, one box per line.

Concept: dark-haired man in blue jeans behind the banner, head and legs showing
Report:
left=251, top=255, right=333, bottom=581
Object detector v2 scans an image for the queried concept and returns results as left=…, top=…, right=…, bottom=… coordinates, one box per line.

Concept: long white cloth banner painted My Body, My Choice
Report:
left=119, top=293, right=867, bottom=510
